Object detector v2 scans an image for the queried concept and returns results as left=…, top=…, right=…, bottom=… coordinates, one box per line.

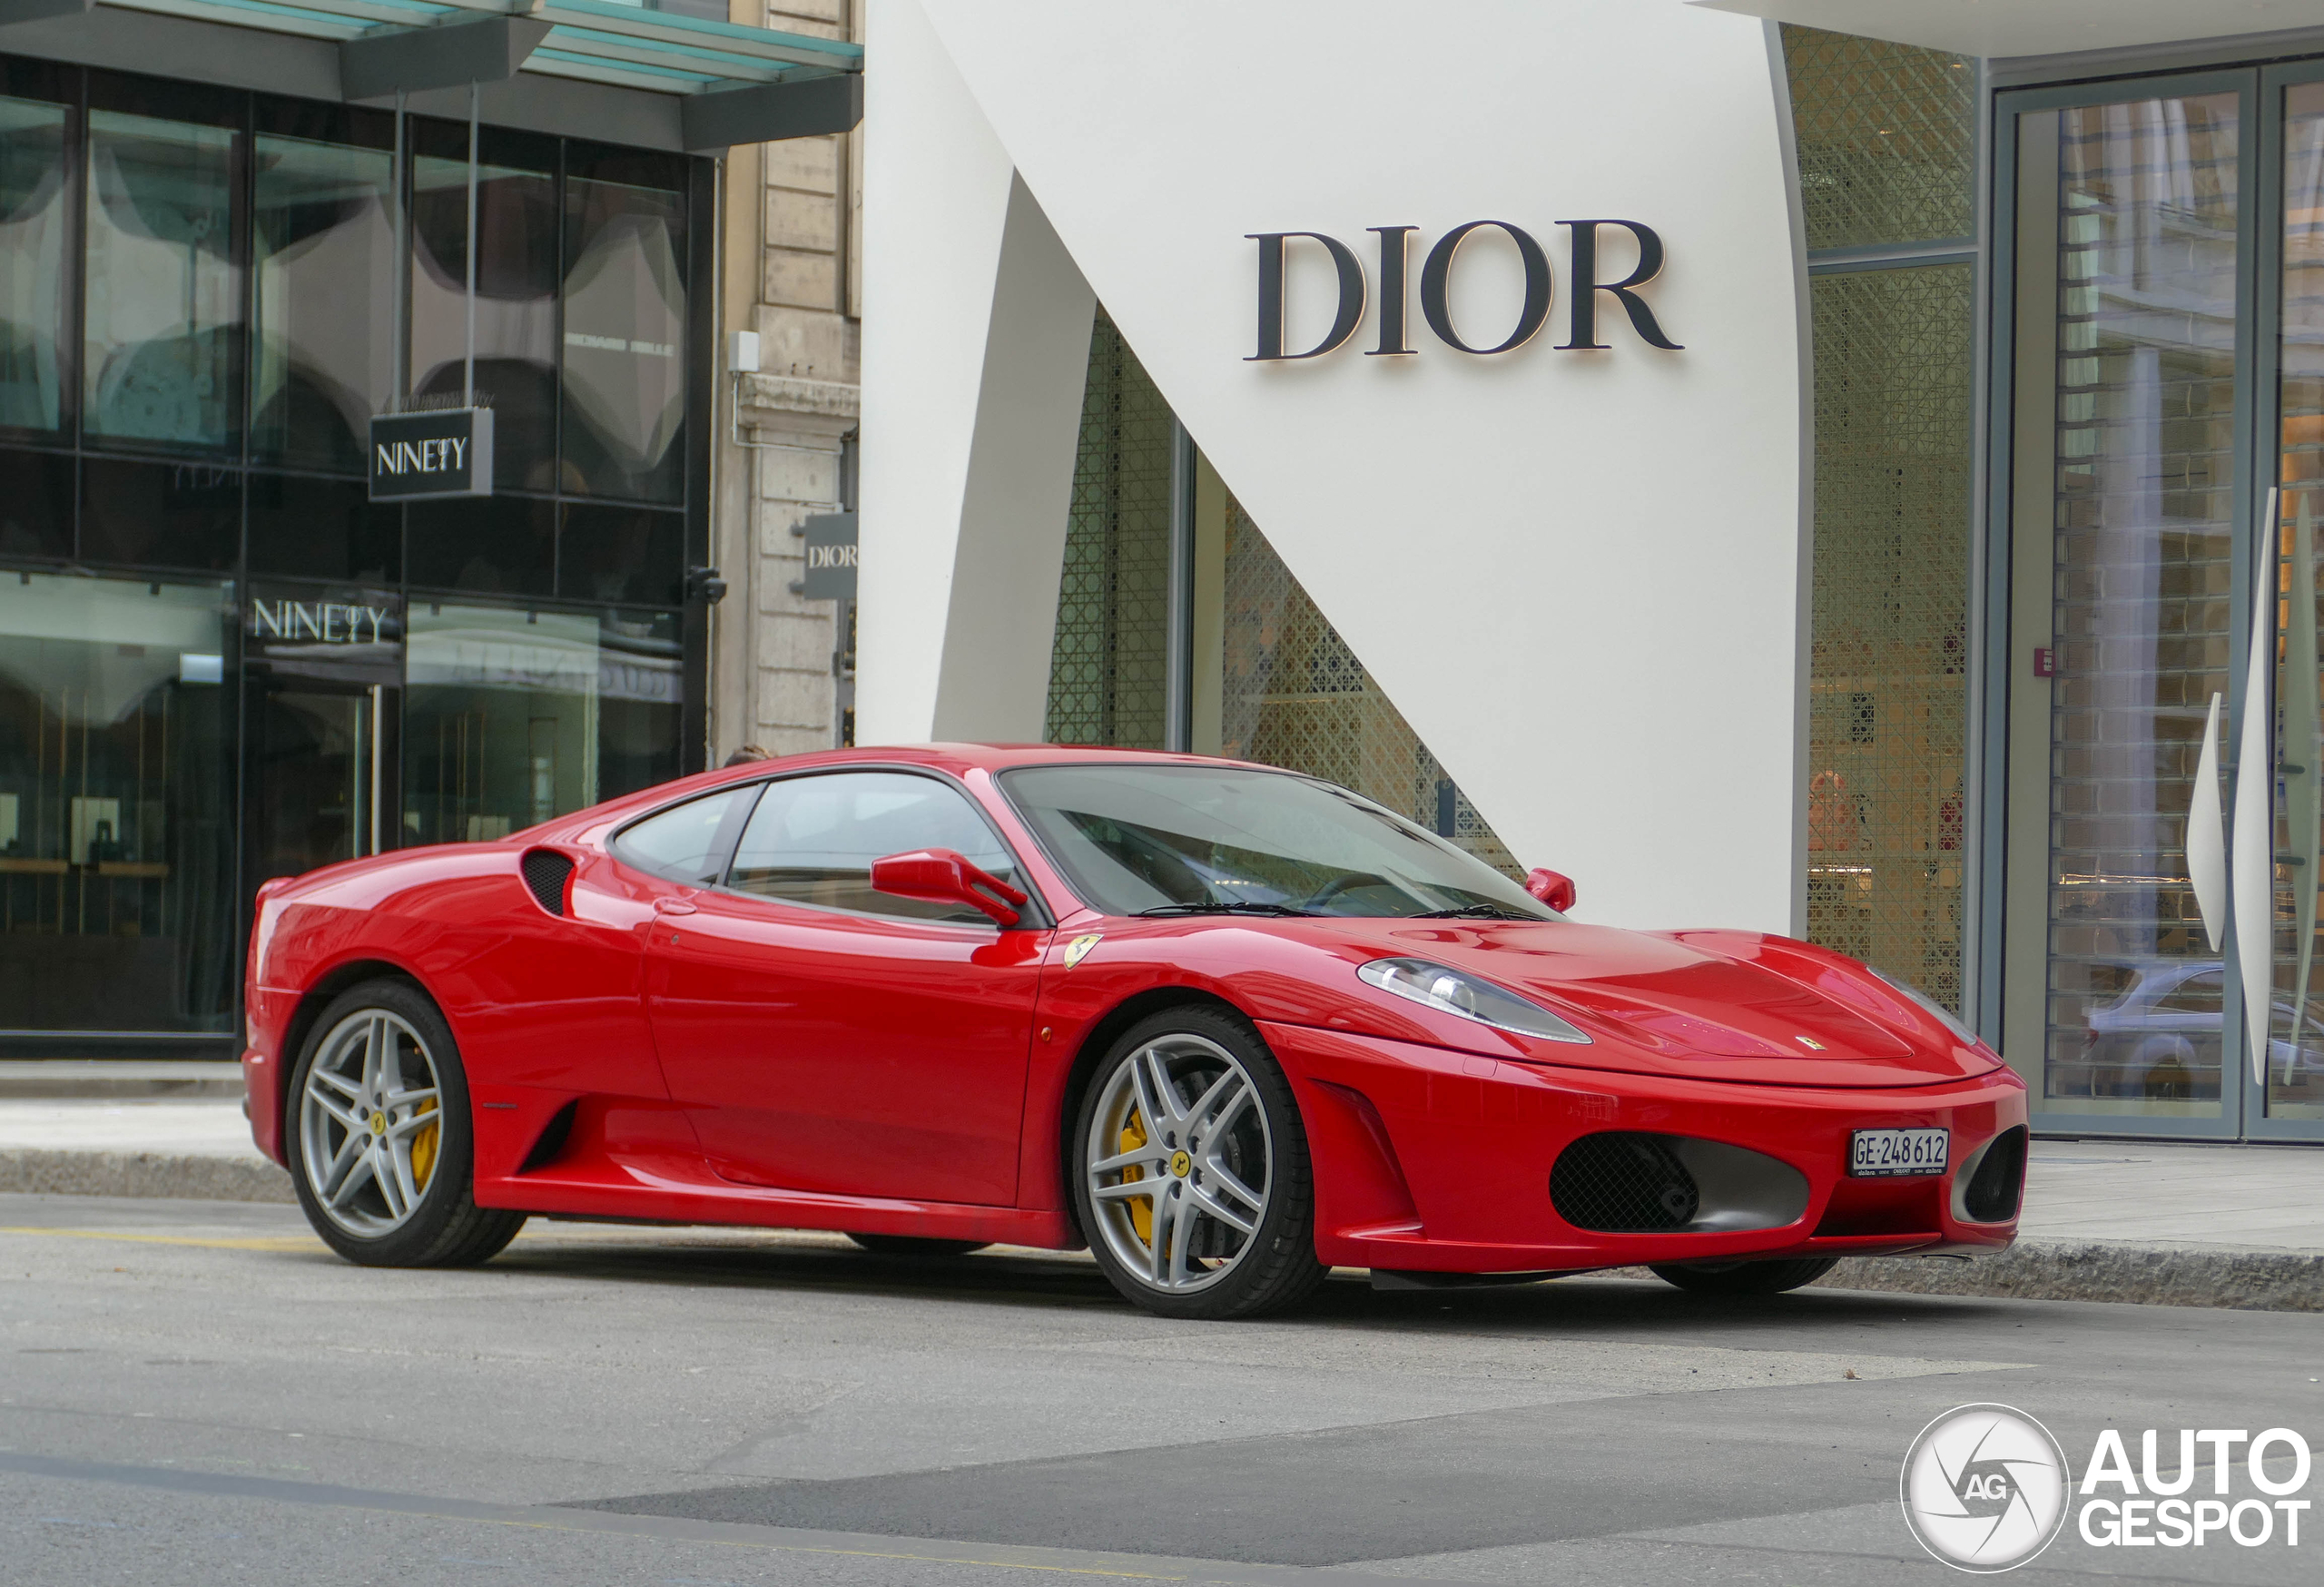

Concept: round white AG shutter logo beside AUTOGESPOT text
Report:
left=1899, top=1405, right=2071, bottom=1575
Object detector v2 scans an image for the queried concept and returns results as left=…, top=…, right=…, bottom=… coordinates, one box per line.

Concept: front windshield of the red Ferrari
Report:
left=1000, top=764, right=1561, bottom=920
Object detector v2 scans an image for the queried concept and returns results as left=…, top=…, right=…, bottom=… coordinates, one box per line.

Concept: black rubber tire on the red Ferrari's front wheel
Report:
left=1064, top=1004, right=1329, bottom=1320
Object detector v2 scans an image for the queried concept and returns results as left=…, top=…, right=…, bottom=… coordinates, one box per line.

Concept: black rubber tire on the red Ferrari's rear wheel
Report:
left=283, top=978, right=526, bottom=1267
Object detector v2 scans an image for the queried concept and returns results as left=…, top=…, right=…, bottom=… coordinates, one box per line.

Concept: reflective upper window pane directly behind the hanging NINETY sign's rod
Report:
left=411, top=121, right=557, bottom=490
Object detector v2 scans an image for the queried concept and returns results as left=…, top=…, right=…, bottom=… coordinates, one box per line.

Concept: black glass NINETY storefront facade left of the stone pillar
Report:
left=0, top=0, right=860, bottom=1055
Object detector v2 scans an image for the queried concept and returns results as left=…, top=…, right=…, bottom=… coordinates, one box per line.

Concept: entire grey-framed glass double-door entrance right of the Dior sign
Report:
left=1996, top=63, right=2324, bottom=1138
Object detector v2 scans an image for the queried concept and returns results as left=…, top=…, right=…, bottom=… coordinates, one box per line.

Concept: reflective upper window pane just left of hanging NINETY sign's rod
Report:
left=251, top=134, right=395, bottom=472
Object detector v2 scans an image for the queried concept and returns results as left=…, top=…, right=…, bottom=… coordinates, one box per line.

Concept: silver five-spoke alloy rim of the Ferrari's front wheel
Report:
left=1083, top=1031, right=1275, bottom=1295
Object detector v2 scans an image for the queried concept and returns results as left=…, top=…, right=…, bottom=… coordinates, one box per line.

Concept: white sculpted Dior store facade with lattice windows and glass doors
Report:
left=862, top=0, right=2324, bottom=1141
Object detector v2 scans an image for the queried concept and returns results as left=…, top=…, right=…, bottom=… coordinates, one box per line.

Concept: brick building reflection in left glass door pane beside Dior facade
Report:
left=2020, top=93, right=2238, bottom=1118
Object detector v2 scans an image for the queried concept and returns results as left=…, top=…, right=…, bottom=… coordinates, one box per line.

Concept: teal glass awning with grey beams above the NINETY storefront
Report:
left=22, top=0, right=864, bottom=149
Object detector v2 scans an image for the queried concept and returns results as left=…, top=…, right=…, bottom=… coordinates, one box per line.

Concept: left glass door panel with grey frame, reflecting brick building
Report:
left=2001, top=72, right=2257, bottom=1134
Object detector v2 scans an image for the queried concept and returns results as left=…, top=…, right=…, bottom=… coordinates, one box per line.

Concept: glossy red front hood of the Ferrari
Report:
left=1329, top=920, right=2001, bottom=1085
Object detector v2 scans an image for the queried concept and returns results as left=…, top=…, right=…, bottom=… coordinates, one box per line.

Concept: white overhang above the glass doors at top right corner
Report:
left=1688, top=0, right=2324, bottom=55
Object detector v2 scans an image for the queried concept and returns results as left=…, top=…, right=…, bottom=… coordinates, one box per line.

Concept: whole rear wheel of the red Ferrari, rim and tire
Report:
left=286, top=981, right=526, bottom=1267
